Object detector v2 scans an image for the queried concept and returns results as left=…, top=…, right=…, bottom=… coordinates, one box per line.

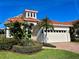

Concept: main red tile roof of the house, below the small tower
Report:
left=8, top=17, right=72, bottom=25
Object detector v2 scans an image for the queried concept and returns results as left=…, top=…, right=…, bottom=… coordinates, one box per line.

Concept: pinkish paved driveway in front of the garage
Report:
left=52, top=42, right=79, bottom=53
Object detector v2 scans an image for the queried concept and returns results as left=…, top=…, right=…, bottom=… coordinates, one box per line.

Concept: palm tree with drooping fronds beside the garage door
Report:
left=33, top=17, right=54, bottom=36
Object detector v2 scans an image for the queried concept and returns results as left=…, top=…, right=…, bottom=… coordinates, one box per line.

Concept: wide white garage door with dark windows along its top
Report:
left=46, top=31, right=70, bottom=43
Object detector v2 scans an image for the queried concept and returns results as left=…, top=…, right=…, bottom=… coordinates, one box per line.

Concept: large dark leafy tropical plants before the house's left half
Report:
left=5, top=21, right=31, bottom=46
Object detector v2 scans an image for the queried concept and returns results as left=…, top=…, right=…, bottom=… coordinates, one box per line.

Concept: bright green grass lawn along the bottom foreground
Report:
left=0, top=49, right=79, bottom=59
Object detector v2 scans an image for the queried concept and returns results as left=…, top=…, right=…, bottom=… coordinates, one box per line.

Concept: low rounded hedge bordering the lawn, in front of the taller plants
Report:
left=12, top=43, right=42, bottom=53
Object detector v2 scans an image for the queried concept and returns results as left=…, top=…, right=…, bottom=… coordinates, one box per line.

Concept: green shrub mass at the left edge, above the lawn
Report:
left=0, top=35, right=16, bottom=50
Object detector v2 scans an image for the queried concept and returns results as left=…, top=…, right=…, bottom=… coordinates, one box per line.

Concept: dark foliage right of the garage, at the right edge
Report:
left=70, top=20, right=79, bottom=41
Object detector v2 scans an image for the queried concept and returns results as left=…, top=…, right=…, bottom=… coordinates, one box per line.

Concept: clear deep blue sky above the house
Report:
left=0, top=0, right=79, bottom=28
